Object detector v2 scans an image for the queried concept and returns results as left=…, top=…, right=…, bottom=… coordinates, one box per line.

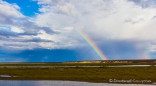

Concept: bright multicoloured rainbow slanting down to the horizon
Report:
left=74, top=28, right=107, bottom=60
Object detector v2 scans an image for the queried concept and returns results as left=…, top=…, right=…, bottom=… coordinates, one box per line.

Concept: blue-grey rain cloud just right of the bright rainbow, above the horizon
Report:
left=100, top=40, right=144, bottom=59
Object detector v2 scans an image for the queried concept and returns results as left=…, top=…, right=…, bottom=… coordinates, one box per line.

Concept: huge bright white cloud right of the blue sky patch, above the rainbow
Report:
left=33, top=0, right=156, bottom=43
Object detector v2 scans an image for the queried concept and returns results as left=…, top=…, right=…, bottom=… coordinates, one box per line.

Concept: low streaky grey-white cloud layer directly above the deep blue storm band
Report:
left=0, top=36, right=53, bottom=50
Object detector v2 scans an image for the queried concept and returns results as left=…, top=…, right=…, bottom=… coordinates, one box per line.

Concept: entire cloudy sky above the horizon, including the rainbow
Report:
left=0, top=0, right=156, bottom=62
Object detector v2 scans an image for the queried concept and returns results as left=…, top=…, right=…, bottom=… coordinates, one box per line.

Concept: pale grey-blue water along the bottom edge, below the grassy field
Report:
left=0, top=80, right=154, bottom=86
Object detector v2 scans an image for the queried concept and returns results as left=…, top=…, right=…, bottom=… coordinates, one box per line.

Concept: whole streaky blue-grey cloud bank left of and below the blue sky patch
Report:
left=0, top=0, right=58, bottom=50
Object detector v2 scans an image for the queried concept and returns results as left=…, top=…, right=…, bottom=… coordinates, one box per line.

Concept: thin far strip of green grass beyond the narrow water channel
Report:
left=0, top=62, right=156, bottom=66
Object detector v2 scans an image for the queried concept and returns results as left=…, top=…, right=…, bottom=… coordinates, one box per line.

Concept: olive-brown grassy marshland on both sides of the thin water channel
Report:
left=0, top=63, right=156, bottom=84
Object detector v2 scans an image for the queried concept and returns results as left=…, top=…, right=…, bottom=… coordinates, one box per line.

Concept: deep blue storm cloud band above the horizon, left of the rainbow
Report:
left=0, top=48, right=80, bottom=62
